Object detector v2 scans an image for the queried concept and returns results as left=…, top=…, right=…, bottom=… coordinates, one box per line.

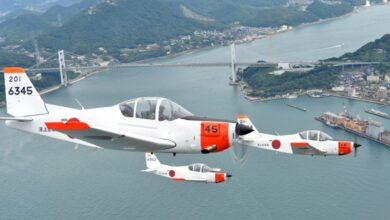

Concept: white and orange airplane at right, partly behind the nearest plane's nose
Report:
left=237, top=115, right=361, bottom=156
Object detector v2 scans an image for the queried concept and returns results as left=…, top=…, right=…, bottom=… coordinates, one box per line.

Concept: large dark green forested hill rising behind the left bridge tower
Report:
left=35, top=0, right=219, bottom=53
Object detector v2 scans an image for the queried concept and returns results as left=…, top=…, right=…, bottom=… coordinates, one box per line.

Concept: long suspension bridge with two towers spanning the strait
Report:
left=0, top=44, right=380, bottom=87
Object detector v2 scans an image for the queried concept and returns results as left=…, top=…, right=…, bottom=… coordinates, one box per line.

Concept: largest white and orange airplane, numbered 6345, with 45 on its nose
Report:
left=0, top=67, right=253, bottom=155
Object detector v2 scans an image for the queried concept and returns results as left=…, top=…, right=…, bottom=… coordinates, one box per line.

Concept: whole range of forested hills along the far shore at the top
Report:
left=0, top=0, right=378, bottom=55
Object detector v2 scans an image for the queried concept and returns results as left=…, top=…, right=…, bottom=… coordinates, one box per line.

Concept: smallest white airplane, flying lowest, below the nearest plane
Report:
left=142, top=153, right=232, bottom=183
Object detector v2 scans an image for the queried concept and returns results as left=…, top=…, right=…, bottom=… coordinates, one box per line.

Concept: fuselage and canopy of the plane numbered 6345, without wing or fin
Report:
left=6, top=98, right=236, bottom=153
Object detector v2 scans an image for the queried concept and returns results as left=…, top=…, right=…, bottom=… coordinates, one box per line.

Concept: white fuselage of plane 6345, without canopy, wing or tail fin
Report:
left=6, top=104, right=235, bottom=153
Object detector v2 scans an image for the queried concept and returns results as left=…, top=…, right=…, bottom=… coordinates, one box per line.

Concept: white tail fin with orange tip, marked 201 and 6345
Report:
left=3, top=67, right=49, bottom=117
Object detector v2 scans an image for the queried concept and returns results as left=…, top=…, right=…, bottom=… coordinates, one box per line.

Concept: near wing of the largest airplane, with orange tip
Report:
left=46, top=120, right=176, bottom=152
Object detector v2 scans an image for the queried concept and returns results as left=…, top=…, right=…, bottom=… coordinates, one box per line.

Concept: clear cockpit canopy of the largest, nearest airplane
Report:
left=119, top=97, right=193, bottom=121
